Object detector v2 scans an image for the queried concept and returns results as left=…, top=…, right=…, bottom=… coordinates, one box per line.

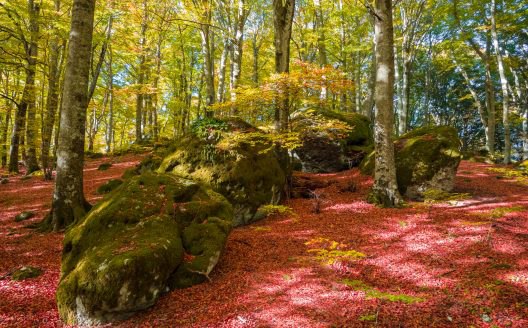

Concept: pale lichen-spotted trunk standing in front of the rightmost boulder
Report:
left=369, top=0, right=402, bottom=207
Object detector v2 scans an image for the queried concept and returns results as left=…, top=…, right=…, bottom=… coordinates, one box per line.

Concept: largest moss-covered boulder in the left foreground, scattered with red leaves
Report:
left=57, top=172, right=233, bottom=326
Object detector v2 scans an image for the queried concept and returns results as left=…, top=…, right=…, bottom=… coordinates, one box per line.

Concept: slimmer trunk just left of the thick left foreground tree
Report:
left=40, top=0, right=61, bottom=180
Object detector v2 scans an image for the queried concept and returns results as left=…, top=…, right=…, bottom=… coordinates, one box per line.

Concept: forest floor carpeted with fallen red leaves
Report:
left=0, top=155, right=528, bottom=327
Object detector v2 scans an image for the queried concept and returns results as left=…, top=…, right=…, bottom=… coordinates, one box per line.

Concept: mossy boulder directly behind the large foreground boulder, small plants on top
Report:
left=158, top=119, right=286, bottom=226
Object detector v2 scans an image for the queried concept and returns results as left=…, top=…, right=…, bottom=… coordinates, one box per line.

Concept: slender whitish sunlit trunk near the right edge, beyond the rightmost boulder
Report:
left=491, top=0, right=512, bottom=164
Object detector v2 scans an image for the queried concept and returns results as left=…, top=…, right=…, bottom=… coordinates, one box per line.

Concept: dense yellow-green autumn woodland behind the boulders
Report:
left=0, top=0, right=528, bottom=172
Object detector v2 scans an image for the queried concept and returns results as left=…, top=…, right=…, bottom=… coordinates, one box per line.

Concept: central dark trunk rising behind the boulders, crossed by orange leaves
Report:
left=273, top=0, right=295, bottom=131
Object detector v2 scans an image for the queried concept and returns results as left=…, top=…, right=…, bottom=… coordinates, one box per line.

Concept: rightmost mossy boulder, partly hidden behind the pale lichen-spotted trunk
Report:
left=360, top=126, right=462, bottom=200
